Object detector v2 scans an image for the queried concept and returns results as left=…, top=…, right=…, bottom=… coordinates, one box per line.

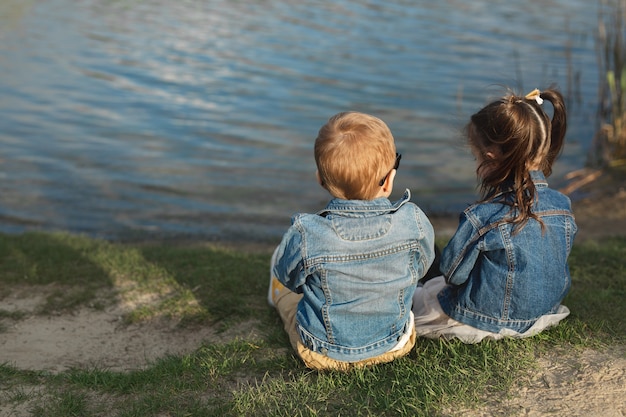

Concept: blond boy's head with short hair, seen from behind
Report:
left=315, top=112, right=396, bottom=200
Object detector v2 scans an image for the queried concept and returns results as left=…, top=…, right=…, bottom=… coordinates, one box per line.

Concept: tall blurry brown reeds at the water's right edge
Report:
left=592, top=0, right=626, bottom=167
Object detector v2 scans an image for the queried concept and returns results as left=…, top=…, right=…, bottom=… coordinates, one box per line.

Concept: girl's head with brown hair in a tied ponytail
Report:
left=466, top=89, right=567, bottom=226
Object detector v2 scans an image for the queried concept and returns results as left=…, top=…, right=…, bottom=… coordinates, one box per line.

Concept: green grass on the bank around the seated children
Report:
left=0, top=234, right=626, bottom=417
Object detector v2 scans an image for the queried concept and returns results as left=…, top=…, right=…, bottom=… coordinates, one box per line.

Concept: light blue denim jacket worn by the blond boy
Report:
left=273, top=190, right=434, bottom=362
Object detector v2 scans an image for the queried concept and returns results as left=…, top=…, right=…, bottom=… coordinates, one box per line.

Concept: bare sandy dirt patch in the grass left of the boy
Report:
left=0, top=288, right=258, bottom=372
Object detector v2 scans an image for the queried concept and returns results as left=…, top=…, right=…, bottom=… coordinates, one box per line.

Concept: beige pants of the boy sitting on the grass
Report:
left=274, top=287, right=416, bottom=371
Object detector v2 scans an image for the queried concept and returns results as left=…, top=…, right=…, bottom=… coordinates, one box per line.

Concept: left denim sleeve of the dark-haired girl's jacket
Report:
left=441, top=213, right=480, bottom=285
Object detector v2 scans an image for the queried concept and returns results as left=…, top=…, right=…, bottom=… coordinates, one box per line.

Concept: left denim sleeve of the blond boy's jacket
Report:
left=272, top=221, right=306, bottom=293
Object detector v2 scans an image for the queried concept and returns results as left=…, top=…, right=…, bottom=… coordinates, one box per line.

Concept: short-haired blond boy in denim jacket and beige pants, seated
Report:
left=268, top=112, right=434, bottom=370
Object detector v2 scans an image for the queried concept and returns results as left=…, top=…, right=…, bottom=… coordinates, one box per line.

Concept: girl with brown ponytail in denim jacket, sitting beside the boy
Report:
left=413, top=89, right=577, bottom=343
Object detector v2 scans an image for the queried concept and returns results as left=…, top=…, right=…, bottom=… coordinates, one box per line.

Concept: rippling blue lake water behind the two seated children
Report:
left=0, top=0, right=598, bottom=239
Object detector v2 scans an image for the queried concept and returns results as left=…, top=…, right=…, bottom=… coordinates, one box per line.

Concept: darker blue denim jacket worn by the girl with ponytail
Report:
left=438, top=171, right=577, bottom=333
